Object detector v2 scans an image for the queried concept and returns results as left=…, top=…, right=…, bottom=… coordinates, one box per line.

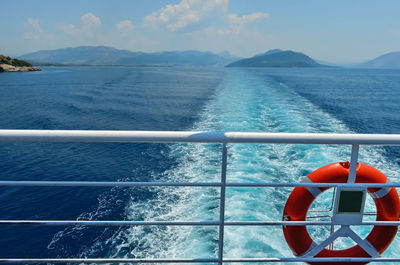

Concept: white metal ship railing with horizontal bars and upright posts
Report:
left=0, top=130, right=400, bottom=264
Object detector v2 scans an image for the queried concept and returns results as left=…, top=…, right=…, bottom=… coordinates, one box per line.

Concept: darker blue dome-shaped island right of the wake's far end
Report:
left=226, top=49, right=330, bottom=67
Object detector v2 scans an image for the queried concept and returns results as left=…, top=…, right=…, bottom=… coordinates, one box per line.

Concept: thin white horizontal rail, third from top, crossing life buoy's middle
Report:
left=0, top=220, right=400, bottom=226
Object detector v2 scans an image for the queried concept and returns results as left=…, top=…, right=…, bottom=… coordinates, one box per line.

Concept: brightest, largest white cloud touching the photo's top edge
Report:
left=144, top=0, right=229, bottom=31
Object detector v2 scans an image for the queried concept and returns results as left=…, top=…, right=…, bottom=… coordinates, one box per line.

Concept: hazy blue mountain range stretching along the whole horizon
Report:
left=18, top=46, right=400, bottom=69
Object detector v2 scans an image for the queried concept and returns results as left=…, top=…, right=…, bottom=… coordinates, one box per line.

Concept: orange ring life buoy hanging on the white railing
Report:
left=283, top=162, right=400, bottom=265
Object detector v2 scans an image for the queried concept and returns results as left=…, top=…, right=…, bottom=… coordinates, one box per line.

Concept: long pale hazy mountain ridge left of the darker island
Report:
left=20, top=46, right=238, bottom=66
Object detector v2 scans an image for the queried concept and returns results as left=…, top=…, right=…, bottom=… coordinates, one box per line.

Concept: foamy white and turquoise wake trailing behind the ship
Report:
left=105, top=69, right=400, bottom=258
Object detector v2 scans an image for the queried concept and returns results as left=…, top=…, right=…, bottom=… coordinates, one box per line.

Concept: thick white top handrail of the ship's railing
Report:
left=0, top=130, right=400, bottom=145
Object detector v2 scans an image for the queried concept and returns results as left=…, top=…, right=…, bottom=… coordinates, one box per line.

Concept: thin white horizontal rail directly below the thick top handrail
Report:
left=0, top=180, right=400, bottom=189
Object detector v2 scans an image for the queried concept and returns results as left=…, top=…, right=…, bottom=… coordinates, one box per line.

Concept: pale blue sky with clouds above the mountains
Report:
left=0, top=0, right=400, bottom=63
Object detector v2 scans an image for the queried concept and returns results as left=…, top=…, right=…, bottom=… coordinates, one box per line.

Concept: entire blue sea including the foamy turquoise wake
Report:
left=0, top=67, right=400, bottom=258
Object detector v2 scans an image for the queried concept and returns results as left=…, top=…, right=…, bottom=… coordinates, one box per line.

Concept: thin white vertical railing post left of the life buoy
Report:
left=218, top=143, right=228, bottom=265
